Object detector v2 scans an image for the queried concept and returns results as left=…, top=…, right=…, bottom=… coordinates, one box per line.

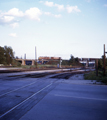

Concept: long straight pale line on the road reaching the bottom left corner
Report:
left=0, top=83, right=52, bottom=118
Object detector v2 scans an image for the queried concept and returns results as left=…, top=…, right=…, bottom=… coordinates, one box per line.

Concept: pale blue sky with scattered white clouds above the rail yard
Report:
left=0, top=0, right=107, bottom=59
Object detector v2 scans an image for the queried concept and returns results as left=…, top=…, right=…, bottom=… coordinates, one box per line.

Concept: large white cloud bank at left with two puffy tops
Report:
left=0, top=7, right=42, bottom=28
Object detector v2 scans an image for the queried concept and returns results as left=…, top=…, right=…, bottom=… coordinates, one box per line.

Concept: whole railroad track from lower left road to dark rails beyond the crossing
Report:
left=0, top=71, right=91, bottom=120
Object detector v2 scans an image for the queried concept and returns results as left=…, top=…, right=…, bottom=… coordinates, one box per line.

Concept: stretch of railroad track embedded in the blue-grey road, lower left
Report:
left=0, top=72, right=62, bottom=120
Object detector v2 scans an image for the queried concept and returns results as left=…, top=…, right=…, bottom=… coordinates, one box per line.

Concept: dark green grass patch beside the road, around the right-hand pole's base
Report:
left=84, top=71, right=107, bottom=85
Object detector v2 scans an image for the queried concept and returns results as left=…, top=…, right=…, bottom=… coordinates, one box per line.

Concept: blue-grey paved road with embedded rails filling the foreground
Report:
left=0, top=71, right=107, bottom=120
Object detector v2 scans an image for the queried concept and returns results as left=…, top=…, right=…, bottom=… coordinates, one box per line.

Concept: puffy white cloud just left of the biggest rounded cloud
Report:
left=4, top=8, right=24, bottom=17
